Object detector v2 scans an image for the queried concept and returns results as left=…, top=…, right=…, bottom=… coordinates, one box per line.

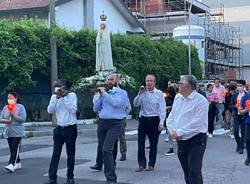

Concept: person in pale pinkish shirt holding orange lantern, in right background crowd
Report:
left=213, top=79, right=226, bottom=128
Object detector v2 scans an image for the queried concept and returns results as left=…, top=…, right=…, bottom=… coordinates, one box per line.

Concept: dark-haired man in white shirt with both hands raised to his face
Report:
left=47, top=80, right=77, bottom=184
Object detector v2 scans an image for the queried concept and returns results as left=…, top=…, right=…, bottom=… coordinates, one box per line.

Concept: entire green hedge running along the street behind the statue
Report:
left=0, top=19, right=201, bottom=90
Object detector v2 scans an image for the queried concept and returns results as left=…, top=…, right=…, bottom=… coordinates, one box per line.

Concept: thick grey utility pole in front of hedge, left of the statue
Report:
left=49, top=0, right=58, bottom=126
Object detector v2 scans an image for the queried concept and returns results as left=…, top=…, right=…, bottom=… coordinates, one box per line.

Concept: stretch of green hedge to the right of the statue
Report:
left=112, top=35, right=201, bottom=88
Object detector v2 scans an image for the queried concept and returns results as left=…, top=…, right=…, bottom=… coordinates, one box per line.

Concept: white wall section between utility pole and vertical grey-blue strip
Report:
left=56, top=0, right=84, bottom=30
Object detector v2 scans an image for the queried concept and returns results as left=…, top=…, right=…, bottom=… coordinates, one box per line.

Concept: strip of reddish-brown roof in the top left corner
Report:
left=0, top=0, right=49, bottom=11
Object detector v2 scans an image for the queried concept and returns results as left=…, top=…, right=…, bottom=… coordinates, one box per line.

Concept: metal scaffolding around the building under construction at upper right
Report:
left=124, top=0, right=243, bottom=79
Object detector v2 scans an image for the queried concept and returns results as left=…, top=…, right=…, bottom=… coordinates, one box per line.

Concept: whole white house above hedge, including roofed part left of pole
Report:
left=0, top=0, right=144, bottom=34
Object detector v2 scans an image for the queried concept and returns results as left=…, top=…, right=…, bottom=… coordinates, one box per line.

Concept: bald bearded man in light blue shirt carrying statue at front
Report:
left=93, top=74, right=128, bottom=184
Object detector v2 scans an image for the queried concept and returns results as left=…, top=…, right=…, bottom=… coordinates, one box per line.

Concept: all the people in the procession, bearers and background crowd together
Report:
left=0, top=74, right=250, bottom=184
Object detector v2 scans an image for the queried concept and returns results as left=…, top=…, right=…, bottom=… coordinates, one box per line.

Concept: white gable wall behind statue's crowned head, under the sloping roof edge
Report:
left=94, top=0, right=135, bottom=33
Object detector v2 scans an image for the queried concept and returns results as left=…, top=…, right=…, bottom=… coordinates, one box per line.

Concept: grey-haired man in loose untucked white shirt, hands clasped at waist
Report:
left=166, top=75, right=209, bottom=184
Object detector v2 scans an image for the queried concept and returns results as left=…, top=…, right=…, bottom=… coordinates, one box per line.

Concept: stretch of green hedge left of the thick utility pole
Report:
left=0, top=20, right=49, bottom=90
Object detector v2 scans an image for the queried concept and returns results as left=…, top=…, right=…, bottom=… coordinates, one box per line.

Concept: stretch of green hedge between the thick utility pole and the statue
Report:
left=55, top=28, right=96, bottom=83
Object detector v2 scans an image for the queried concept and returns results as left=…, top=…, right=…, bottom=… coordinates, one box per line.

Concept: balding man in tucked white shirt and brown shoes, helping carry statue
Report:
left=134, top=75, right=166, bottom=172
